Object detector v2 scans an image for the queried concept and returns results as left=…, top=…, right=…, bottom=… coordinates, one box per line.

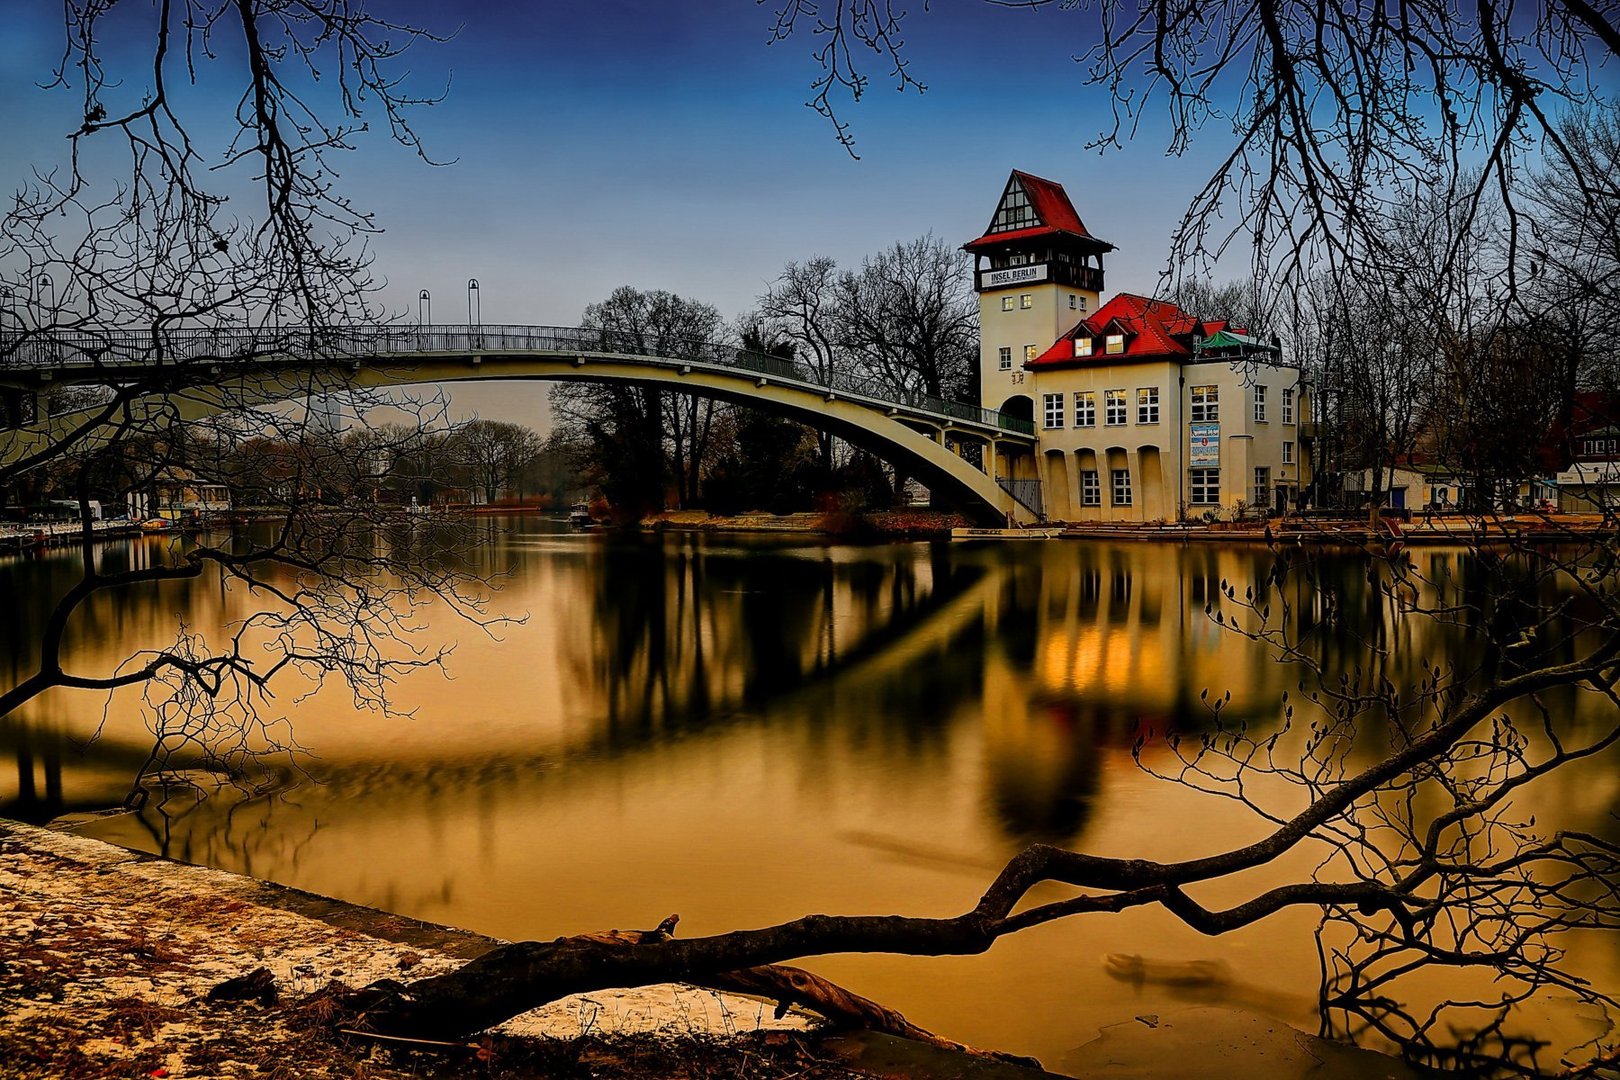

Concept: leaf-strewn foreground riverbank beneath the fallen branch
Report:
left=0, top=819, right=1414, bottom=1080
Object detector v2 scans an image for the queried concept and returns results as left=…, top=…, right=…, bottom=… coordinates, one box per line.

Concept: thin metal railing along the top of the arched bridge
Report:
left=0, top=324, right=1035, bottom=436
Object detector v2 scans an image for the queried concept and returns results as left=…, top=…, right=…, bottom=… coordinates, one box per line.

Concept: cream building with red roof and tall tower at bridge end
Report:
left=964, top=170, right=1311, bottom=521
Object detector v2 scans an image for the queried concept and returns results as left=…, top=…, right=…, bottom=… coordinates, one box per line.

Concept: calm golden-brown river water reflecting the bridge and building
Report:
left=0, top=518, right=1620, bottom=1065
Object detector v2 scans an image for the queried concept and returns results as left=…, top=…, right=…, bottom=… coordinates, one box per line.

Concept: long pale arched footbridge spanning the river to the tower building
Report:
left=0, top=325, right=1040, bottom=525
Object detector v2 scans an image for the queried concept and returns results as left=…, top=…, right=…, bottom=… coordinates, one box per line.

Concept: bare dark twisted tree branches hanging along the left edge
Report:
left=0, top=0, right=488, bottom=793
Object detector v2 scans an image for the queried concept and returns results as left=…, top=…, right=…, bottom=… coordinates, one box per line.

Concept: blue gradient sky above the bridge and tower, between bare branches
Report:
left=0, top=0, right=1221, bottom=413
